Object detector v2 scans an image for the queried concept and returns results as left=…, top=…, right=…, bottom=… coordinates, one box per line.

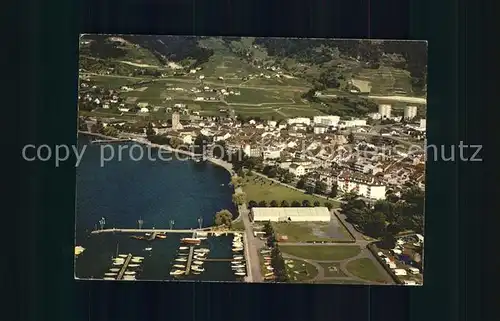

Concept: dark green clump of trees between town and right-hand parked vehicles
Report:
left=341, top=186, right=424, bottom=247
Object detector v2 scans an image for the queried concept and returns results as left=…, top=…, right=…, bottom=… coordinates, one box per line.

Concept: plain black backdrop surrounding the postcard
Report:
left=7, top=0, right=492, bottom=321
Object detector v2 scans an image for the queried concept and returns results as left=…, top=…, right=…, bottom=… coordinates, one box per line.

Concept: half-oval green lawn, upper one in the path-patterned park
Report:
left=279, top=245, right=361, bottom=261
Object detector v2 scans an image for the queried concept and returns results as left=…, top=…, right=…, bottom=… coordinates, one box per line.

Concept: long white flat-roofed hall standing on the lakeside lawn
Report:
left=251, top=207, right=331, bottom=222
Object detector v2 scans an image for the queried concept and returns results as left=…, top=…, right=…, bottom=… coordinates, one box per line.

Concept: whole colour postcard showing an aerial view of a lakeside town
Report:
left=74, top=34, right=427, bottom=285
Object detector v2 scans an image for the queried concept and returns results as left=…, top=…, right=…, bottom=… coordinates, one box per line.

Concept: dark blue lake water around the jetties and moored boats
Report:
left=75, top=135, right=239, bottom=281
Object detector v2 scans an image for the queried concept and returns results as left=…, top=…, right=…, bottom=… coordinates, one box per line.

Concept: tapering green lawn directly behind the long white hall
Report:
left=242, top=176, right=328, bottom=204
